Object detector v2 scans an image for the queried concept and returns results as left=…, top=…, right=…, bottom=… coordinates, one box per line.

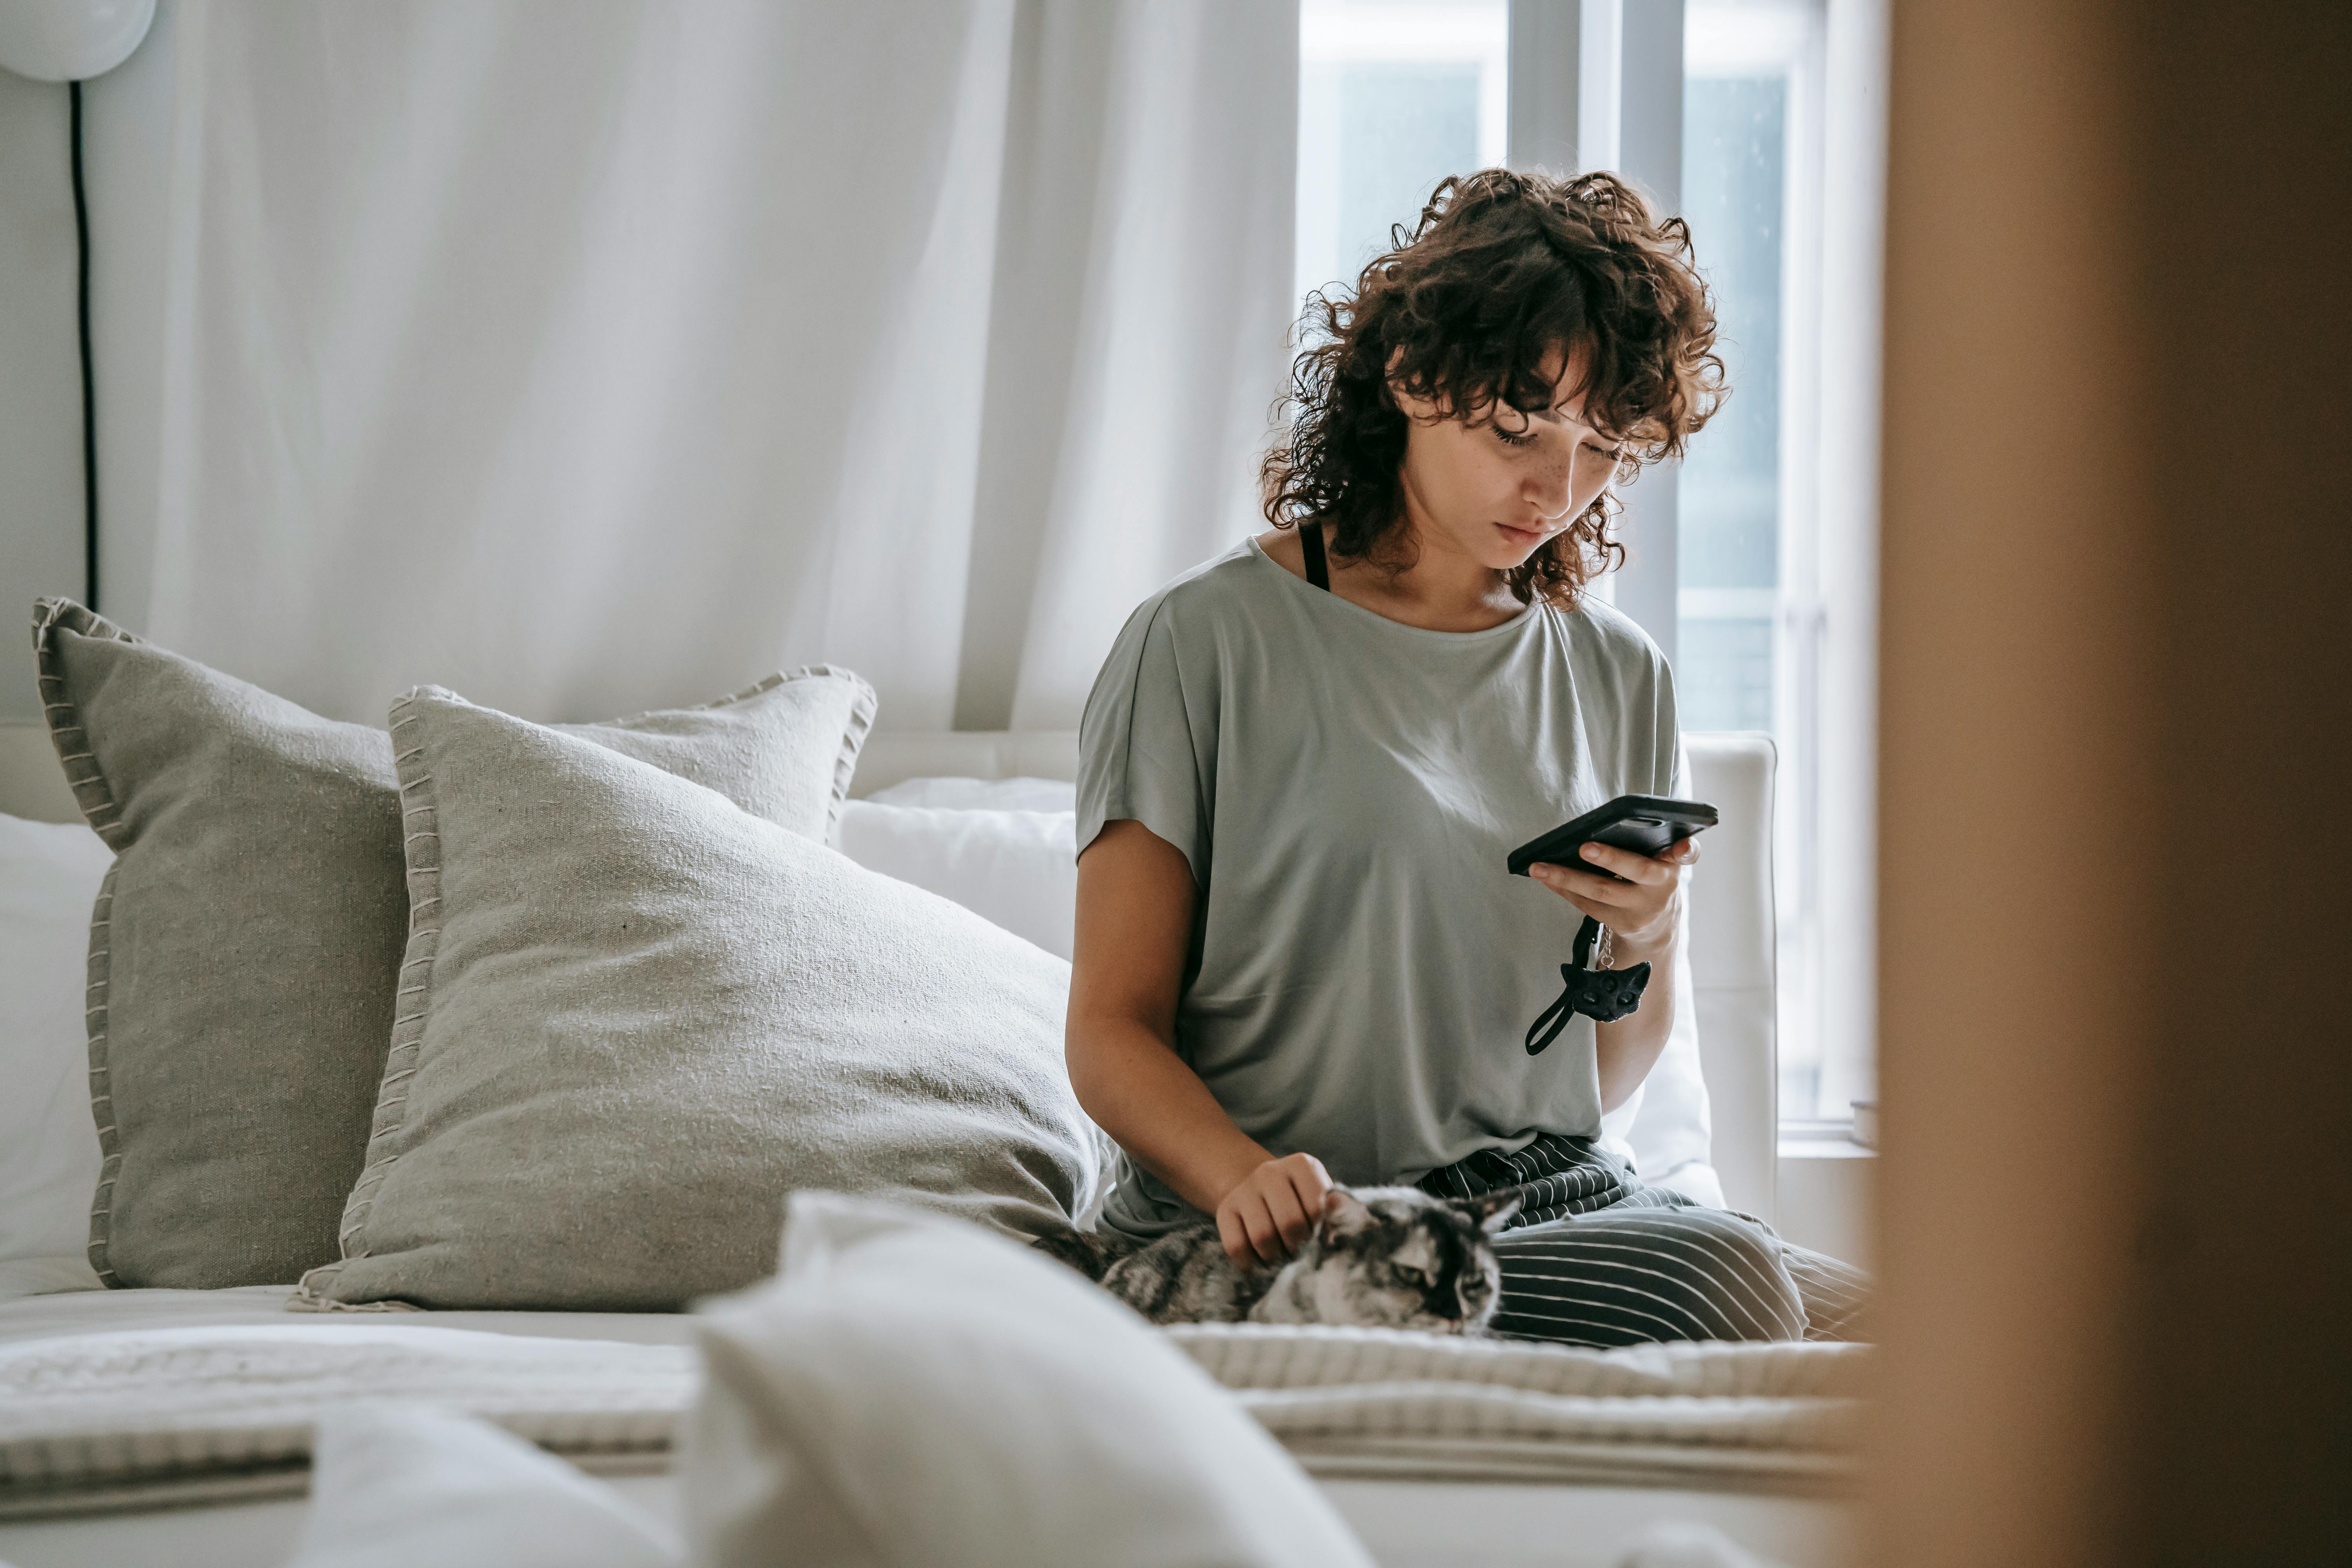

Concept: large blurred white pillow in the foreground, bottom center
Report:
left=680, top=1192, right=1371, bottom=1568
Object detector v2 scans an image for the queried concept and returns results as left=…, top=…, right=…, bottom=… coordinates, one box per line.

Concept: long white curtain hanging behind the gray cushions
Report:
left=92, top=0, right=1298, bottom=729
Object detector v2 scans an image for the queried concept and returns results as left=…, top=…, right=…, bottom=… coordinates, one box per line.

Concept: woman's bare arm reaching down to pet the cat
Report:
left=1065, top=820, right=1331, bottom=1262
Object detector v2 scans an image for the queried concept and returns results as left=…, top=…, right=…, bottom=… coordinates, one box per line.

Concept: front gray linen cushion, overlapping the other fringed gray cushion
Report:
left=301, top=686, right=1103, bottom=1309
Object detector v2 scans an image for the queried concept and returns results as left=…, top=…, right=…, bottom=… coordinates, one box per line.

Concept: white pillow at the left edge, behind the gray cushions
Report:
left=0, top=816, right=113, bottom=1298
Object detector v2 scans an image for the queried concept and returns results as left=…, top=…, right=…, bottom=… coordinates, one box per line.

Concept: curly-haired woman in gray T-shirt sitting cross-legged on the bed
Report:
left=1068, top=169, right=1860, bottom=1345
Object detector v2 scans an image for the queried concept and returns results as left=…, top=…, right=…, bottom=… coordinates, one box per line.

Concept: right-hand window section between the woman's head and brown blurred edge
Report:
left=1675, top=0, right=1867, bottom=1122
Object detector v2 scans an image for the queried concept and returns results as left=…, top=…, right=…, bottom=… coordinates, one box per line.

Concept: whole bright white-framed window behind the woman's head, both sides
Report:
left=1298, top=0, right=1884, bottom=1122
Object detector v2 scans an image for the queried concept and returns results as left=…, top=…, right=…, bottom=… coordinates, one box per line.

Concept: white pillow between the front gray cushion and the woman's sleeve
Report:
left=837, top=808, right=1077, bottom=959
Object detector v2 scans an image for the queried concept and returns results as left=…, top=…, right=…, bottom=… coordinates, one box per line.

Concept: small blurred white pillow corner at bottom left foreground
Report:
left=287, top=1403, right=684, bottom=1568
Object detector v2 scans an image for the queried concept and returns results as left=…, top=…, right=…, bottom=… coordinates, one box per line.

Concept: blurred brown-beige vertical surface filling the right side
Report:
left=1872, top=0, right=2352, bottom=1566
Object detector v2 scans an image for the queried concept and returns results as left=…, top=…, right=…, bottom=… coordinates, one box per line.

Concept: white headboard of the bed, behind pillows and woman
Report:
left=0, top=722, right=1780, bottom=1220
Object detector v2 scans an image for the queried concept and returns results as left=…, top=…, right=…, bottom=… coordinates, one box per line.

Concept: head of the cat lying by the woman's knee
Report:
left=1298, top=1187, right=1522, bottom=1333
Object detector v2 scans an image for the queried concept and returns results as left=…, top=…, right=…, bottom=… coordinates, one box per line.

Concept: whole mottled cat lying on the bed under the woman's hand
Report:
left=1037, top=1187, right=1519, bottom=1335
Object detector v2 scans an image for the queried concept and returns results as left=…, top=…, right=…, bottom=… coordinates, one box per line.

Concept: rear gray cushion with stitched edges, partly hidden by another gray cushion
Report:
left=33, top=599, right=873, bottom=1288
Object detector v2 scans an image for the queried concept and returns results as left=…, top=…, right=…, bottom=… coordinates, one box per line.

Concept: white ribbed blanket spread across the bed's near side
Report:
left=0, top=1290, right=1867, bottom=1516
